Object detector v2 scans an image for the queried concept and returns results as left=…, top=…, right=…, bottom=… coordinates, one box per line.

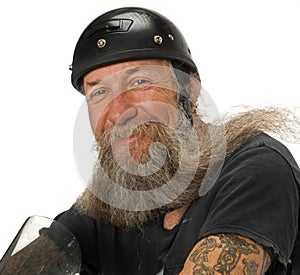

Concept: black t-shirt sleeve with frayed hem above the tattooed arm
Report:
left=199, top=146, right=299, bottom=265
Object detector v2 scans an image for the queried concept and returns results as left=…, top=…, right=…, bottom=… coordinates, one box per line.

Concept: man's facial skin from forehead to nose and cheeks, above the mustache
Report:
left=84, top=60, right=177, bottom=134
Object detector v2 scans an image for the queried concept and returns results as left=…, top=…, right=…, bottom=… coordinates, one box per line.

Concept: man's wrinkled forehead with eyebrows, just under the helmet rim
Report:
left=83, top=59, right=172, bottom=88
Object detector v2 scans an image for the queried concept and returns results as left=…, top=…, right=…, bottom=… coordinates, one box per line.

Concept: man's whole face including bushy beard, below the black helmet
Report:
left=77, top=60, right=204, bottom=227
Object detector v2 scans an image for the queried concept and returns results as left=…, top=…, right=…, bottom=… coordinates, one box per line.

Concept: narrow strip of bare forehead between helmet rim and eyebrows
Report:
left=83, top=59, right=170, bottom=83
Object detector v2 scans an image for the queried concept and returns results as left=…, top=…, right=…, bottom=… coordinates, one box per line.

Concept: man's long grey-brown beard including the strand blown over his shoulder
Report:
left=75, top=108, right=300, bottom=228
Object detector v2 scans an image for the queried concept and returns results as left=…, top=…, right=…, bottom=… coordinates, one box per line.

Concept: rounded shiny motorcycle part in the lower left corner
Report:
left=0, top=217, right=81, bottom=275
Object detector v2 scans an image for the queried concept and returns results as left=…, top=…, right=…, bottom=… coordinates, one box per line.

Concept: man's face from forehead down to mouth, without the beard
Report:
left=84, top=60, right=178, bottom=161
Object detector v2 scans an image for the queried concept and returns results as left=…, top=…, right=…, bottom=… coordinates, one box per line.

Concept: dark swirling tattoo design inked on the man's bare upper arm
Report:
left=189, top=234, right=267, bottom=275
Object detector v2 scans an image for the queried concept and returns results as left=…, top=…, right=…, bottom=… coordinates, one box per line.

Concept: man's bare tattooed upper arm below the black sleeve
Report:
left=180, top=234, right=271, bottom=275
